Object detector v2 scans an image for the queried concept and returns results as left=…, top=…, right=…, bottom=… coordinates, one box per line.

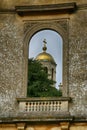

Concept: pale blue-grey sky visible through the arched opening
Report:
left=29, top=30, right=63, bottom=88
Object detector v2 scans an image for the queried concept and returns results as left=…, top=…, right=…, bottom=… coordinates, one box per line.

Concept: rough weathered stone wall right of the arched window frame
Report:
left=69, top=10, right=87, bottom=116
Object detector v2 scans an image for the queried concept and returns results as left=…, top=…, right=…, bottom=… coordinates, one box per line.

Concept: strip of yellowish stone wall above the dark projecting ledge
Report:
left=0, top=0, right=87, bottom=9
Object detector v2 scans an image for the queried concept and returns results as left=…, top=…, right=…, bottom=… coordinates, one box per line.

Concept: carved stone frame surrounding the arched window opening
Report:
left=23, top=19, right=69, bottom=97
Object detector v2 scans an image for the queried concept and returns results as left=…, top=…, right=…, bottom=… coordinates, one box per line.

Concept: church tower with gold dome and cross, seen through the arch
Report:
left=35, top=40, right=56, bottom=85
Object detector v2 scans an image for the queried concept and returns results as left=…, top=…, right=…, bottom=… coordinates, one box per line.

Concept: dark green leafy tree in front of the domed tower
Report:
left=27, top=59, right=61, bottom=97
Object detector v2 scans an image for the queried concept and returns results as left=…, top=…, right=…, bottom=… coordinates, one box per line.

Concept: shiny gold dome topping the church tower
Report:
left=35, top=52, right=56, bottom=64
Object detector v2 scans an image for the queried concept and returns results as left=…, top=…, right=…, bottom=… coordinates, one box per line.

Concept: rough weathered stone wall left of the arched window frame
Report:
left=0, top=14, right=24, bottom=116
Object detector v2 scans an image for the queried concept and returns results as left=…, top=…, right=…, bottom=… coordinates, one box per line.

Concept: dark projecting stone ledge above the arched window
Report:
left=15, top=2, right=77, bottom=15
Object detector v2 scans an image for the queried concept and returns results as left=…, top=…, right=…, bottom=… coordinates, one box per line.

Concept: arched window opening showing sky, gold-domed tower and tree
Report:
left=27, top=29, right=63, bottom=97
